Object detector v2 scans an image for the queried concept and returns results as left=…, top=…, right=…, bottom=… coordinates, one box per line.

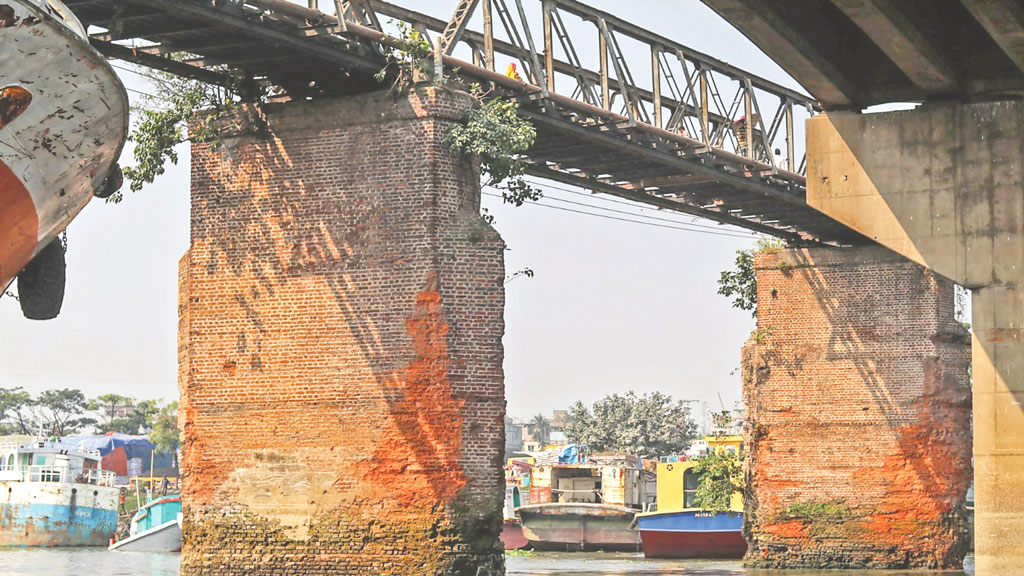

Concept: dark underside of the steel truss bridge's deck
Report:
left=65, top=0, right=866, bottom=244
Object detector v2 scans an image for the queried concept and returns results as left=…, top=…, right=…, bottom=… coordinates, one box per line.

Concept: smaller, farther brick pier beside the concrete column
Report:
left=743, top=247, right=972, bottom=568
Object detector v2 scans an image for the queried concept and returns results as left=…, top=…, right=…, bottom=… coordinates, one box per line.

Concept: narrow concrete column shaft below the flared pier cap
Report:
left=973, top=285, right=1024, bottom=576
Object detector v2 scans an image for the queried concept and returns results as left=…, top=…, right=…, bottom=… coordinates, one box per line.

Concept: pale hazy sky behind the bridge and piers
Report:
left=0, top=0, right=815, bottom=418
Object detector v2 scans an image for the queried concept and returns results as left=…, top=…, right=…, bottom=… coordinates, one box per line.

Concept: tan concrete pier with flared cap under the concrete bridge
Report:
left=807, top=100, right=1024, bottom=576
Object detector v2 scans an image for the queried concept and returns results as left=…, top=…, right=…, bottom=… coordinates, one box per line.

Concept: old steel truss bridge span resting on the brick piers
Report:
left=65, top=0, right=866, bottom=244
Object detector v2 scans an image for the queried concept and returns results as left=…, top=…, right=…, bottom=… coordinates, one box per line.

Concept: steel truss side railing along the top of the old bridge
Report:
left=325, top=0, right=820, bottom=174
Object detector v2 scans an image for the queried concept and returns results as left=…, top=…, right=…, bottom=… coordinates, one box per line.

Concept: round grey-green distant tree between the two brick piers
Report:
left=564, top=392, right=696, bottom=457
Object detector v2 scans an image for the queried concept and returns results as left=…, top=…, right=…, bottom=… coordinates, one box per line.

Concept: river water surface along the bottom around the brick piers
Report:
left=0, top=549, right=973, bottom=576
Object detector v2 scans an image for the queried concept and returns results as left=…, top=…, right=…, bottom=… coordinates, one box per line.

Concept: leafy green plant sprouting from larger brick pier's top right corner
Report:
left=443, top=86, right=543, bottom=206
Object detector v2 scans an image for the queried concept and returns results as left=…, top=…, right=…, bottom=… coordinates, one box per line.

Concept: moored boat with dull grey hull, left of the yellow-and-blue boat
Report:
left=516, top=451, right=654, bottom=551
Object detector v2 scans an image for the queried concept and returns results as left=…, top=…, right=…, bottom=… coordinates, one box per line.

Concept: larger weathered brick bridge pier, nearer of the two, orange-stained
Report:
left=180, top=88, right=505, bottom=576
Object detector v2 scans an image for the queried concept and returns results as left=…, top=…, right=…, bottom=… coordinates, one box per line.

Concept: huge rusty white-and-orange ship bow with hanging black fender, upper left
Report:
left=0, top=0, right=128, bottom=320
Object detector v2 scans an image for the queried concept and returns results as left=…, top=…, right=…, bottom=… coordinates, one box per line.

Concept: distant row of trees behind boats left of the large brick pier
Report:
left=0, top=386, right=178, bottom=452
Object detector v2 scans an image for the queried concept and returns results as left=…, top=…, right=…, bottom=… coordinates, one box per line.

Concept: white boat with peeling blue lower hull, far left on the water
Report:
left=0, top=441, right=120, bottom=547
